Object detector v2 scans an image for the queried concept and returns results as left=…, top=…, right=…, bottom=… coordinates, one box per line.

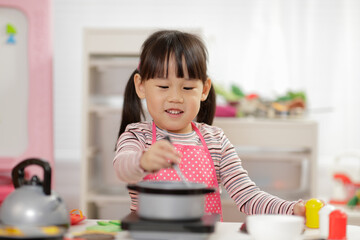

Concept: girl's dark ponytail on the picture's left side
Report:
left=118, top=69, right=145, bottom=138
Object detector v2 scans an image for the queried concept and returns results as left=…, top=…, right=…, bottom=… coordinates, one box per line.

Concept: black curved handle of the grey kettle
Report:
left=11, top=158, right=51, bottom=195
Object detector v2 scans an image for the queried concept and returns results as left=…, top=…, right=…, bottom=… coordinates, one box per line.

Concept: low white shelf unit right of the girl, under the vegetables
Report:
left=213, top=118, right=318, bottom=221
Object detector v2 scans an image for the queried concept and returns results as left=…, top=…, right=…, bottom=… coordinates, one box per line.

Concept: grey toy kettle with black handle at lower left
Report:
left=0, top=158, right=70, bottom=227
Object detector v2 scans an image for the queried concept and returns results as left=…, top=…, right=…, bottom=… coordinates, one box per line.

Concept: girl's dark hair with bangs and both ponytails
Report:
left=118, top=30, right=216, bottom=142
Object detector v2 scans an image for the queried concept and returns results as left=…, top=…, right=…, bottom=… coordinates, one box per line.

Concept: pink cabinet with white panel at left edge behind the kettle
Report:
left=0, top=0, right=54, bottom=201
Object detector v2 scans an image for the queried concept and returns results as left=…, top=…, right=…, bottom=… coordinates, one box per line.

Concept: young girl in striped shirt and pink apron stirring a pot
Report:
left=113, top=31, right=305, bottom=219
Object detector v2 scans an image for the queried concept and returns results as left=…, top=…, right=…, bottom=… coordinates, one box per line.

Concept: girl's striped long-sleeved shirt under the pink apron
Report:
left=113, top=122, right=296, bottom=215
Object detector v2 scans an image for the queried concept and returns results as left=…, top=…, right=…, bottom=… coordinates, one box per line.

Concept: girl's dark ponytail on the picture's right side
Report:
left=196, top=84, right=216, bottom=125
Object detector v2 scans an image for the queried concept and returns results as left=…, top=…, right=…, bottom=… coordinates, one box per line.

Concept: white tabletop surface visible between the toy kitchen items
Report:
left=66, top=219, right=360, bottom=240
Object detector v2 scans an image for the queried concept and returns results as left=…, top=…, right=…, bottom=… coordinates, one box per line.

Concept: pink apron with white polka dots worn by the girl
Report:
left=144, top=122, right=222, bottom=221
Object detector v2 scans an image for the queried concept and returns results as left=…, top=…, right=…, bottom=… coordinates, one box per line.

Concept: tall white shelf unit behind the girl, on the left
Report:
left=80, top=29, right=152, bottom=218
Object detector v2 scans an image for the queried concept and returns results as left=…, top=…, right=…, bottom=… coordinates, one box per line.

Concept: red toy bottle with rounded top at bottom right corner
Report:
left=328, top=209, right=347, bottom=240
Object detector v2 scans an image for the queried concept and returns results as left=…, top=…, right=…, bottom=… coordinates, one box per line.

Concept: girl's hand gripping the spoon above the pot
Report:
left=140, top=140, right=181, bottom=172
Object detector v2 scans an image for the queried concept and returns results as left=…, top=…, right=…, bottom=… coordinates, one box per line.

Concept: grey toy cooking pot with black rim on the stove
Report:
left=127, top=181, right=216, bottom=221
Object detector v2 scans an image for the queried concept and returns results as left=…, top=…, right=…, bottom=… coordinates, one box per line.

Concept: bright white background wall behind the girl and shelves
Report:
left=53, top=0, right=360, bottom=167
